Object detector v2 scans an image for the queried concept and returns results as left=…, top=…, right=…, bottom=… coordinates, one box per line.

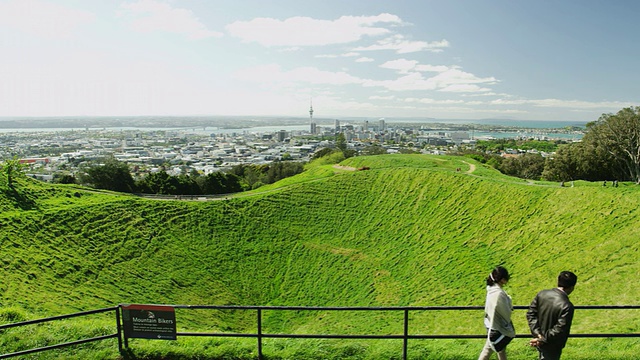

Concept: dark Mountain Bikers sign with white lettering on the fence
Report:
left=121, top=304, right=176, bottom=340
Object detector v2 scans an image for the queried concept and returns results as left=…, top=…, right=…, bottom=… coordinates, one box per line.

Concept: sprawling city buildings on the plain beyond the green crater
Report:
left=0, top=120, right=568, bottom=181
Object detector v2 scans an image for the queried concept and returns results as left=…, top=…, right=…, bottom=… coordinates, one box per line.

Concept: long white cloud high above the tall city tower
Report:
left=227, top=14, right=402, bottom=46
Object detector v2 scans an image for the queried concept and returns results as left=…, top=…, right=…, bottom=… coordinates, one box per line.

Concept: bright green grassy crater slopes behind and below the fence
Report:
left=0, top=155, right=640, bottom=359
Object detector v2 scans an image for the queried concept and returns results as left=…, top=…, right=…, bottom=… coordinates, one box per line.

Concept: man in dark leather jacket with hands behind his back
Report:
left=527, top=271, right=578, bottom=360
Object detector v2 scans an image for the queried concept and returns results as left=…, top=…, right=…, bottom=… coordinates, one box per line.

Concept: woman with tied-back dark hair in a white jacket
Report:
left=478, top=266, right=516, bottom=360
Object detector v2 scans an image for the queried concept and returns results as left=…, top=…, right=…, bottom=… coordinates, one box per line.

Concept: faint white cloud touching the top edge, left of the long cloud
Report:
left=121, top=0, right=222, bottom=40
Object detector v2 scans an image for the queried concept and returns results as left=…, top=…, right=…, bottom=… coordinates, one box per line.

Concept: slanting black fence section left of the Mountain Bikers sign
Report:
left=0, top=306, right=122, bottom=359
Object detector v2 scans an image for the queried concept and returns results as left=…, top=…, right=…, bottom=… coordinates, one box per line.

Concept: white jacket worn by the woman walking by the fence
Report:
left=484, top=284, right=516, bottom=338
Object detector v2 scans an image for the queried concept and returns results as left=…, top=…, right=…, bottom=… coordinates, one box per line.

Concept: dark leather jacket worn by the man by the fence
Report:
left=527, top=288, right=574, bottom=349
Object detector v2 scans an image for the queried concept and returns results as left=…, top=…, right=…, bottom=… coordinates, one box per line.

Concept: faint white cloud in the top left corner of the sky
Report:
left=0, top=0, right=95, bottom=38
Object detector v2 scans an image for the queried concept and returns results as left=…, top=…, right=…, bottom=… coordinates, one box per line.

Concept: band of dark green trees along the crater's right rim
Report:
left=463, top=106, right=640, bottom=184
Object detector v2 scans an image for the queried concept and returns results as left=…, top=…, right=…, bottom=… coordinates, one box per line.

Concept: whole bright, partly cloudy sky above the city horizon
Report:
left=0, top=0, right=640, bottom=121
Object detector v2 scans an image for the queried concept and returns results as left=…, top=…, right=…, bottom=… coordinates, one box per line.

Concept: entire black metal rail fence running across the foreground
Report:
left=0, top=304, right=640, bottom=360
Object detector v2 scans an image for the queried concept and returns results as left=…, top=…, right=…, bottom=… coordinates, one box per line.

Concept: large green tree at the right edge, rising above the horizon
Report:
left=583, top=106, right=640, bottom=184
